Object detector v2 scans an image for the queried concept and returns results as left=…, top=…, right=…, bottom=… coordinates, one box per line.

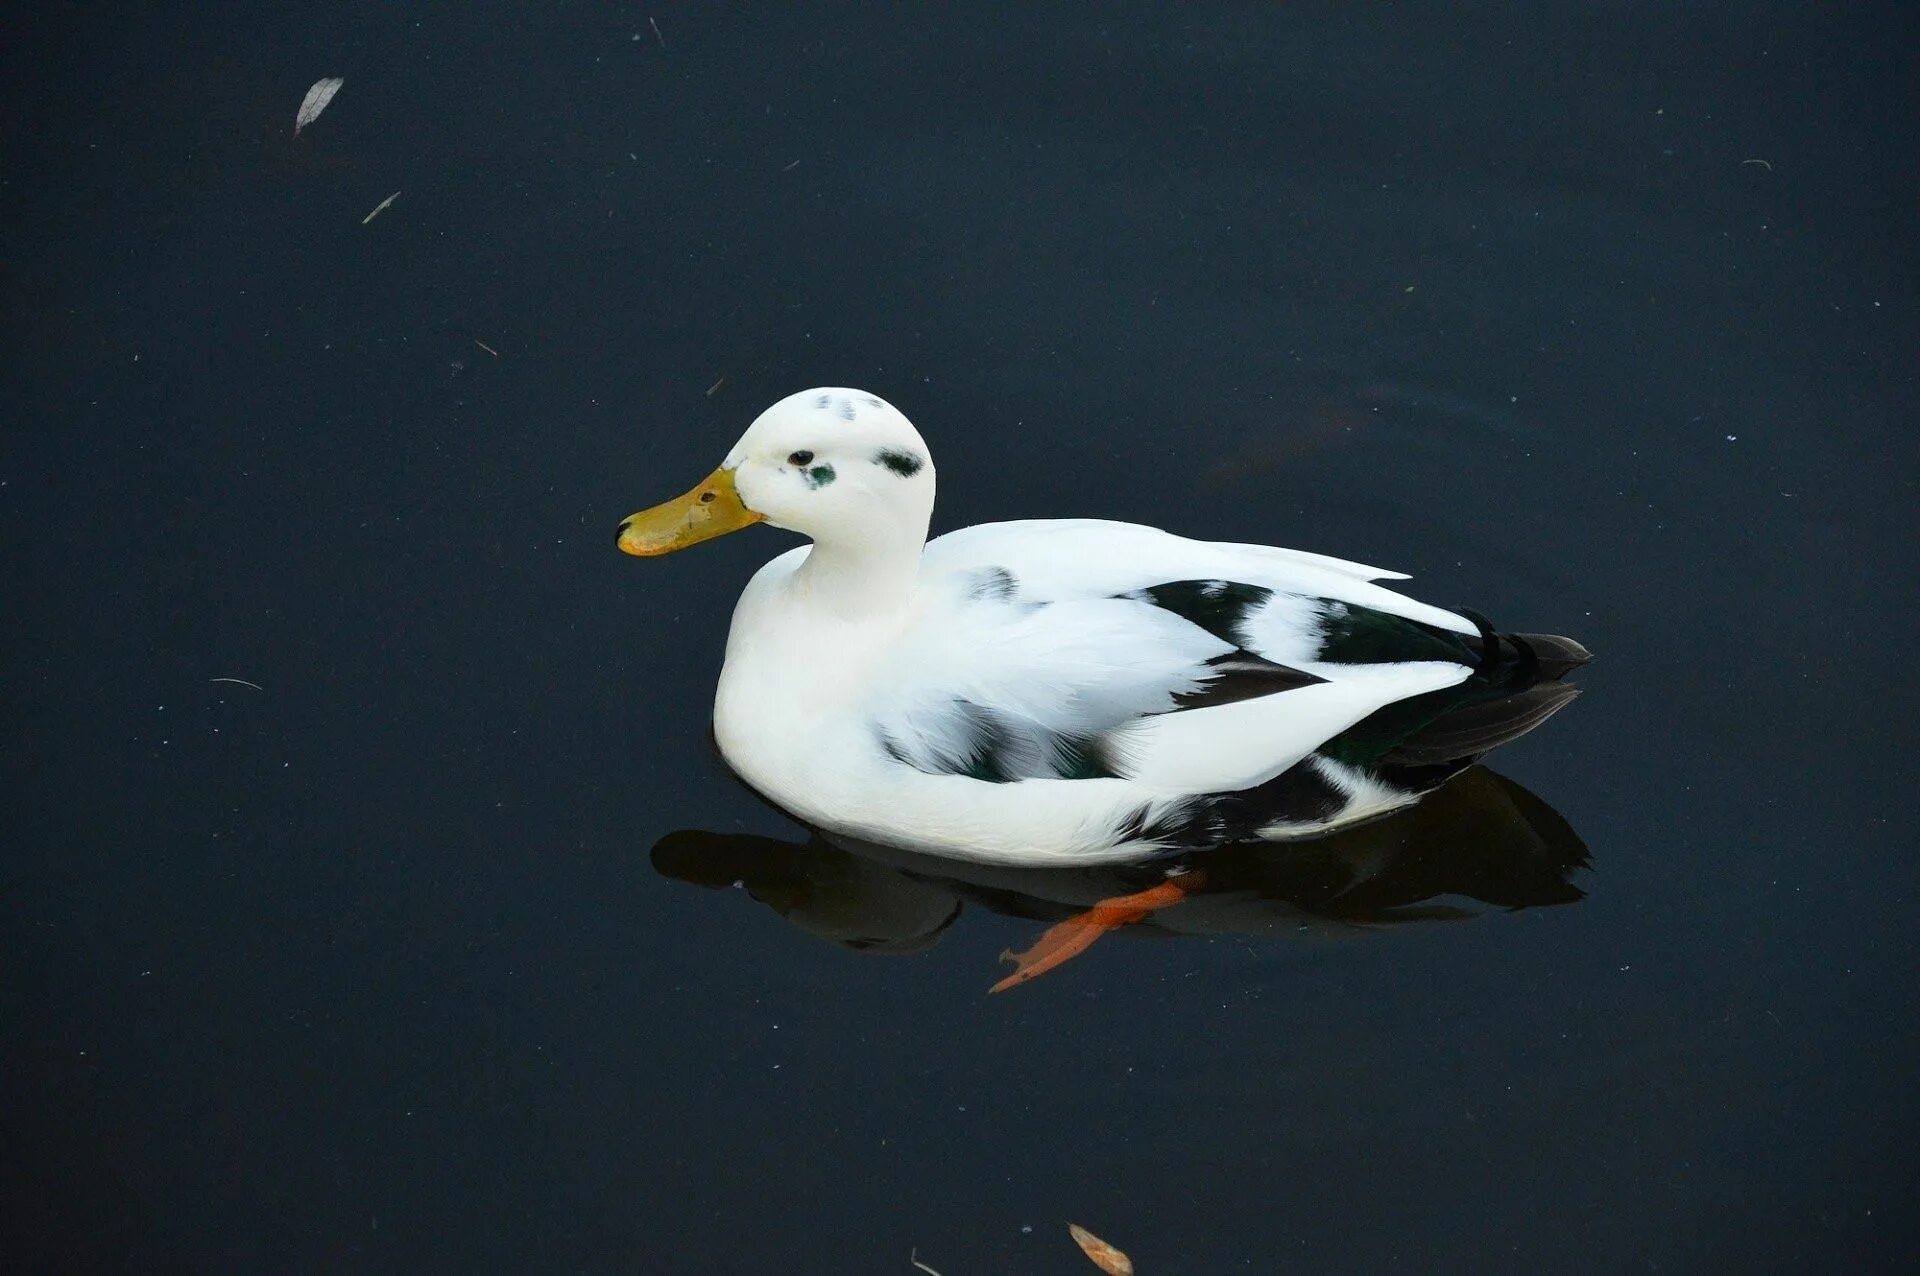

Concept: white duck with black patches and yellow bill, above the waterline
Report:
left=618, top=388, right=1590, bottom=867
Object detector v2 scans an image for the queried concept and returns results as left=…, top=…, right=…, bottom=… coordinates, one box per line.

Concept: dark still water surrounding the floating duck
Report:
left=0, top=4, right=1920, bottom=1276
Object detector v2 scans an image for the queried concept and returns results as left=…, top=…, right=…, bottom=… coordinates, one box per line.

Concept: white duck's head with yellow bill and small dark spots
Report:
left=620, top=390, right=933, bottom=556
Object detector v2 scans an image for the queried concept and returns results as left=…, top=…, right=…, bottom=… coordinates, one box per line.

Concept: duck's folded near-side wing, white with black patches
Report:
left=866, top=522, right=1478, bottom=804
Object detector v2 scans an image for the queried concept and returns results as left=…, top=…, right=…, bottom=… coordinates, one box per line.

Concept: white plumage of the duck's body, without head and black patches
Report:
left=714, top=520, right=1476, bottom=863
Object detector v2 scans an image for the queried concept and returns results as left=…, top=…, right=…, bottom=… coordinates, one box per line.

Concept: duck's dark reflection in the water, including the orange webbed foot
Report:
left=653, top=768, right=1588, bottom=992
